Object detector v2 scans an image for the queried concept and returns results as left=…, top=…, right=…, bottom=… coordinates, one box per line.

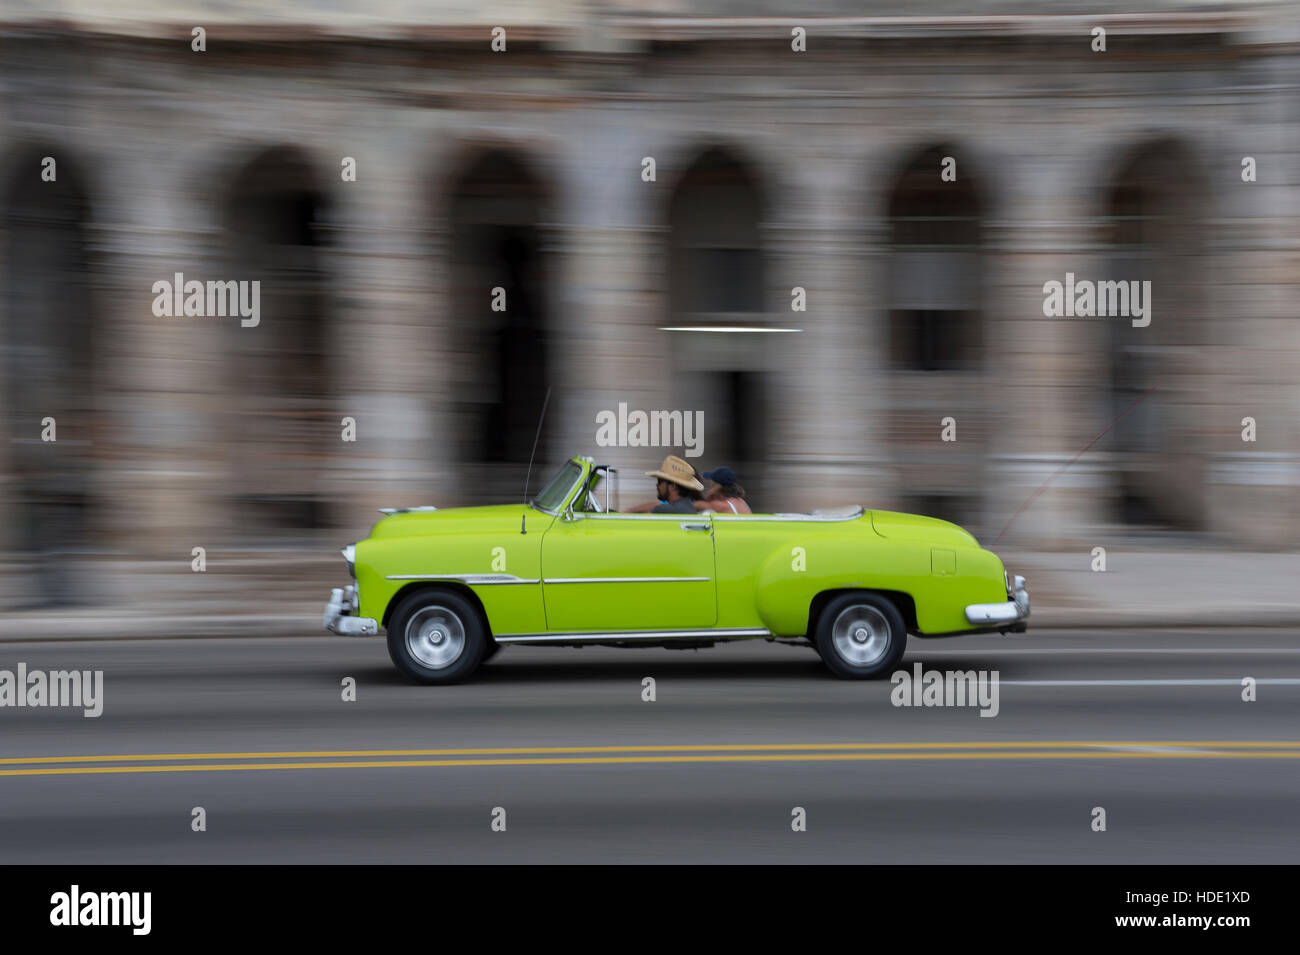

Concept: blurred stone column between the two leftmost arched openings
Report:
left=86, top=137, right=230, bottom=568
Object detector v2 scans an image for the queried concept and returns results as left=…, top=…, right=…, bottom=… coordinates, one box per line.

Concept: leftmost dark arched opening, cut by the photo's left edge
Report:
left=0, top=151, right=100, bottom=604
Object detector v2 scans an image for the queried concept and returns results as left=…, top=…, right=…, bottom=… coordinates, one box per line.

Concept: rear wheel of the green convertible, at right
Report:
left=814, top=594, right=907, bottom=680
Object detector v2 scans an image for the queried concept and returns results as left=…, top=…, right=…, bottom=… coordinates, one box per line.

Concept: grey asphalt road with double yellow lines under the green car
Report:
left=0, top=630, right=1300, bottom=864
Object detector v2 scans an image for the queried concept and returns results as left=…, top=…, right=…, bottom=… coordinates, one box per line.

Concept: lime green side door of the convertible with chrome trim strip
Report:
left=542, top=513, right=718, bottom=633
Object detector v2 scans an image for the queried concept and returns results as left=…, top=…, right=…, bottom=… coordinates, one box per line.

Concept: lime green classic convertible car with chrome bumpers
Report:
left=324, top=456, right=1030, bottom=683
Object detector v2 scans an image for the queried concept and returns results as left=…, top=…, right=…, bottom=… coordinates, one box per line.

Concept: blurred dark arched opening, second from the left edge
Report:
left=220, top=147, right=330, bottom=539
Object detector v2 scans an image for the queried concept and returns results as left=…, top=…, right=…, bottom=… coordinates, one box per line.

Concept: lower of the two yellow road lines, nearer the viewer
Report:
left=0, top=748, right=1300, bottom=776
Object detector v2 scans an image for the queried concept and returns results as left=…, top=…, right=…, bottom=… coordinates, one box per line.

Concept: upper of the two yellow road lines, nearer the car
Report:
left=0, top=739, right=1300, bottom=765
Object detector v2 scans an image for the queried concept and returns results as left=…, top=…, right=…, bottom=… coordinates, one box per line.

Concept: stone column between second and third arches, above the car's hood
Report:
left=326, top=135, right=452, bottom=537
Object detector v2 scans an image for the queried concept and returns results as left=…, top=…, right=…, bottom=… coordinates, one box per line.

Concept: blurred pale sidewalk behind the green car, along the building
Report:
left=0, top=550, right=1300, bottom=642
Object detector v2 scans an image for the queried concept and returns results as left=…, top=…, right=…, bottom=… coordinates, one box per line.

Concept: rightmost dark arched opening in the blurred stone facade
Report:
left=1097, top=139, right=1205, bottom=530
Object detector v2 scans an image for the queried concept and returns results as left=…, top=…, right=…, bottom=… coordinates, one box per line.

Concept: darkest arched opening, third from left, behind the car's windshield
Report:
left=439, top=149, right=555, bottom=502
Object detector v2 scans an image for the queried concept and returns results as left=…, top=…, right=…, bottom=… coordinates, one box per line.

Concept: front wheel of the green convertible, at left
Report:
left=389, top=591, right=491, bottom=683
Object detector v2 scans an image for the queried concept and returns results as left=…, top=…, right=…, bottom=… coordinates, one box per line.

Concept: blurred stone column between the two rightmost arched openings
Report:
left=984, top=146, right=1109, bottom=547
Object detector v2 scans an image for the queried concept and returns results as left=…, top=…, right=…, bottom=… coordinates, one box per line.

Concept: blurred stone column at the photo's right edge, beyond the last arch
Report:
left=1193, top=31, right=1300, bottom=548
